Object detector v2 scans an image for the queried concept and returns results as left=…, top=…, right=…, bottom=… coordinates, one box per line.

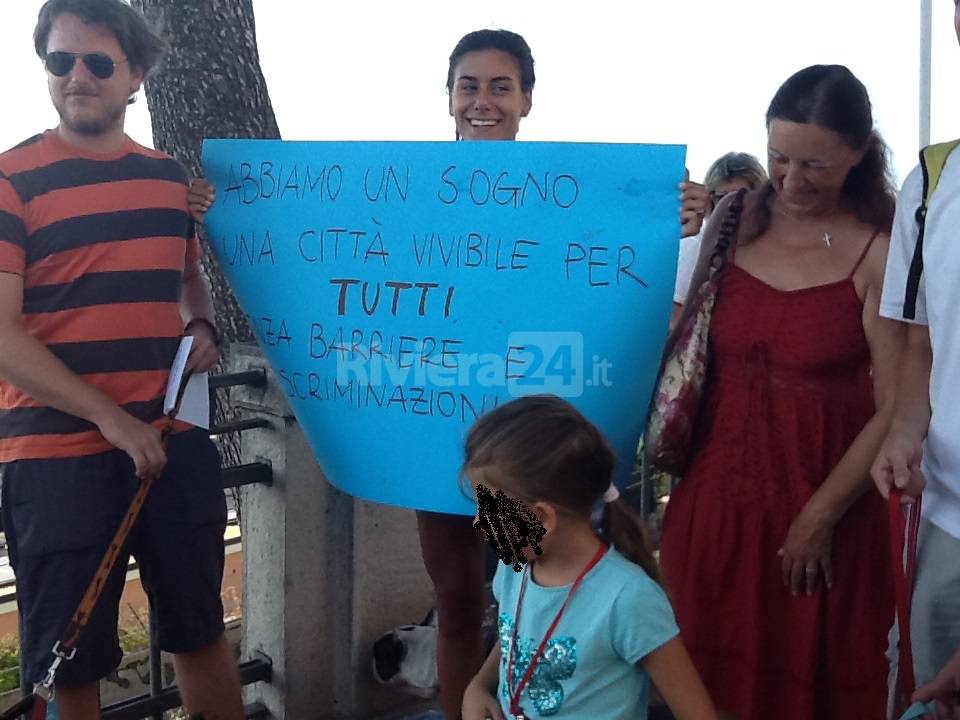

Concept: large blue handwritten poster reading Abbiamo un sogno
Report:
left=203, top=140, right=684, bottom=514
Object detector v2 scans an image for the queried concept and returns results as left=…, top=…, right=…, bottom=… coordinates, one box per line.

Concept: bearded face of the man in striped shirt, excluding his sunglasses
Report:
left=47, top=13, right=143, bottom=136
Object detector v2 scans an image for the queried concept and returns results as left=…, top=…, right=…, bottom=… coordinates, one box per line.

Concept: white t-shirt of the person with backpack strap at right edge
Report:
left=880, top=151, right=960, bottom=539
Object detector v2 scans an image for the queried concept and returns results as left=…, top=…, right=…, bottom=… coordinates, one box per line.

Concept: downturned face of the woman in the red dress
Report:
left=767, top=120, right=864, bottom=216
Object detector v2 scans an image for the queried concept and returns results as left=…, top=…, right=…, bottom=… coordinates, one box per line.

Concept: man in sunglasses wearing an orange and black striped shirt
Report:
left=0, top=0, right=243, bottom=720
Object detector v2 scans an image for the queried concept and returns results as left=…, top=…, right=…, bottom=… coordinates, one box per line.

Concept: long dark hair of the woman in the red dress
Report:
left=760, top=65, right=896, bottom=232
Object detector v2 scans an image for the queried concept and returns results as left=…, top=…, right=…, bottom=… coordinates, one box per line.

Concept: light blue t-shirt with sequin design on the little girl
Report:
left=493, top=548, right=679, bottom=720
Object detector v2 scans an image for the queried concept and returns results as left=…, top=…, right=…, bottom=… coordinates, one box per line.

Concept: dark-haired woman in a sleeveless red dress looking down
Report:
left=661, top=65, right=901, bottom=720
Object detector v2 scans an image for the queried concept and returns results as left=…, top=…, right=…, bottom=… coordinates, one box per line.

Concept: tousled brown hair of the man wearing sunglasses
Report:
left=33, top=0, right=166, bottom=75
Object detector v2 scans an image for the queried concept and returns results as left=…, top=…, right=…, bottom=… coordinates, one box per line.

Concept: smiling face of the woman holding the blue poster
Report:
left=450, top=50, right=533, bottom=140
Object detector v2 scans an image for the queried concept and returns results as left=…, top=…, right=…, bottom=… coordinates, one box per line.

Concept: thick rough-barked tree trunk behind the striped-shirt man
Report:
left=131, top=0, right=280, bottom=464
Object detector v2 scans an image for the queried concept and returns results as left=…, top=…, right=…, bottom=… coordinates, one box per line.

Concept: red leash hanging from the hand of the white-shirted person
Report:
left=888, top=490, right=920, bottom=717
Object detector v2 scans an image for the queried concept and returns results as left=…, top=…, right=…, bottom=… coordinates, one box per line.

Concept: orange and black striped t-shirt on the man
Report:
left=0, top=130, right=200, bottom=463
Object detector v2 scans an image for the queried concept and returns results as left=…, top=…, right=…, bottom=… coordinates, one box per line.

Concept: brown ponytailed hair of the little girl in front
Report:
left=463, top=395, right=659, bottom=580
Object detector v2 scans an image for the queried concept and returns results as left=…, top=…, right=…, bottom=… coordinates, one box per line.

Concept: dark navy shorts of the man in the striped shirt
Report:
left=2, top=429, right=227, bottom=687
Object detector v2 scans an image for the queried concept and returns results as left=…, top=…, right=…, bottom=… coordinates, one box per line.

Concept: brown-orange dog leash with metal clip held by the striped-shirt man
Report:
left=0, top=371, right=192, bottom=720
